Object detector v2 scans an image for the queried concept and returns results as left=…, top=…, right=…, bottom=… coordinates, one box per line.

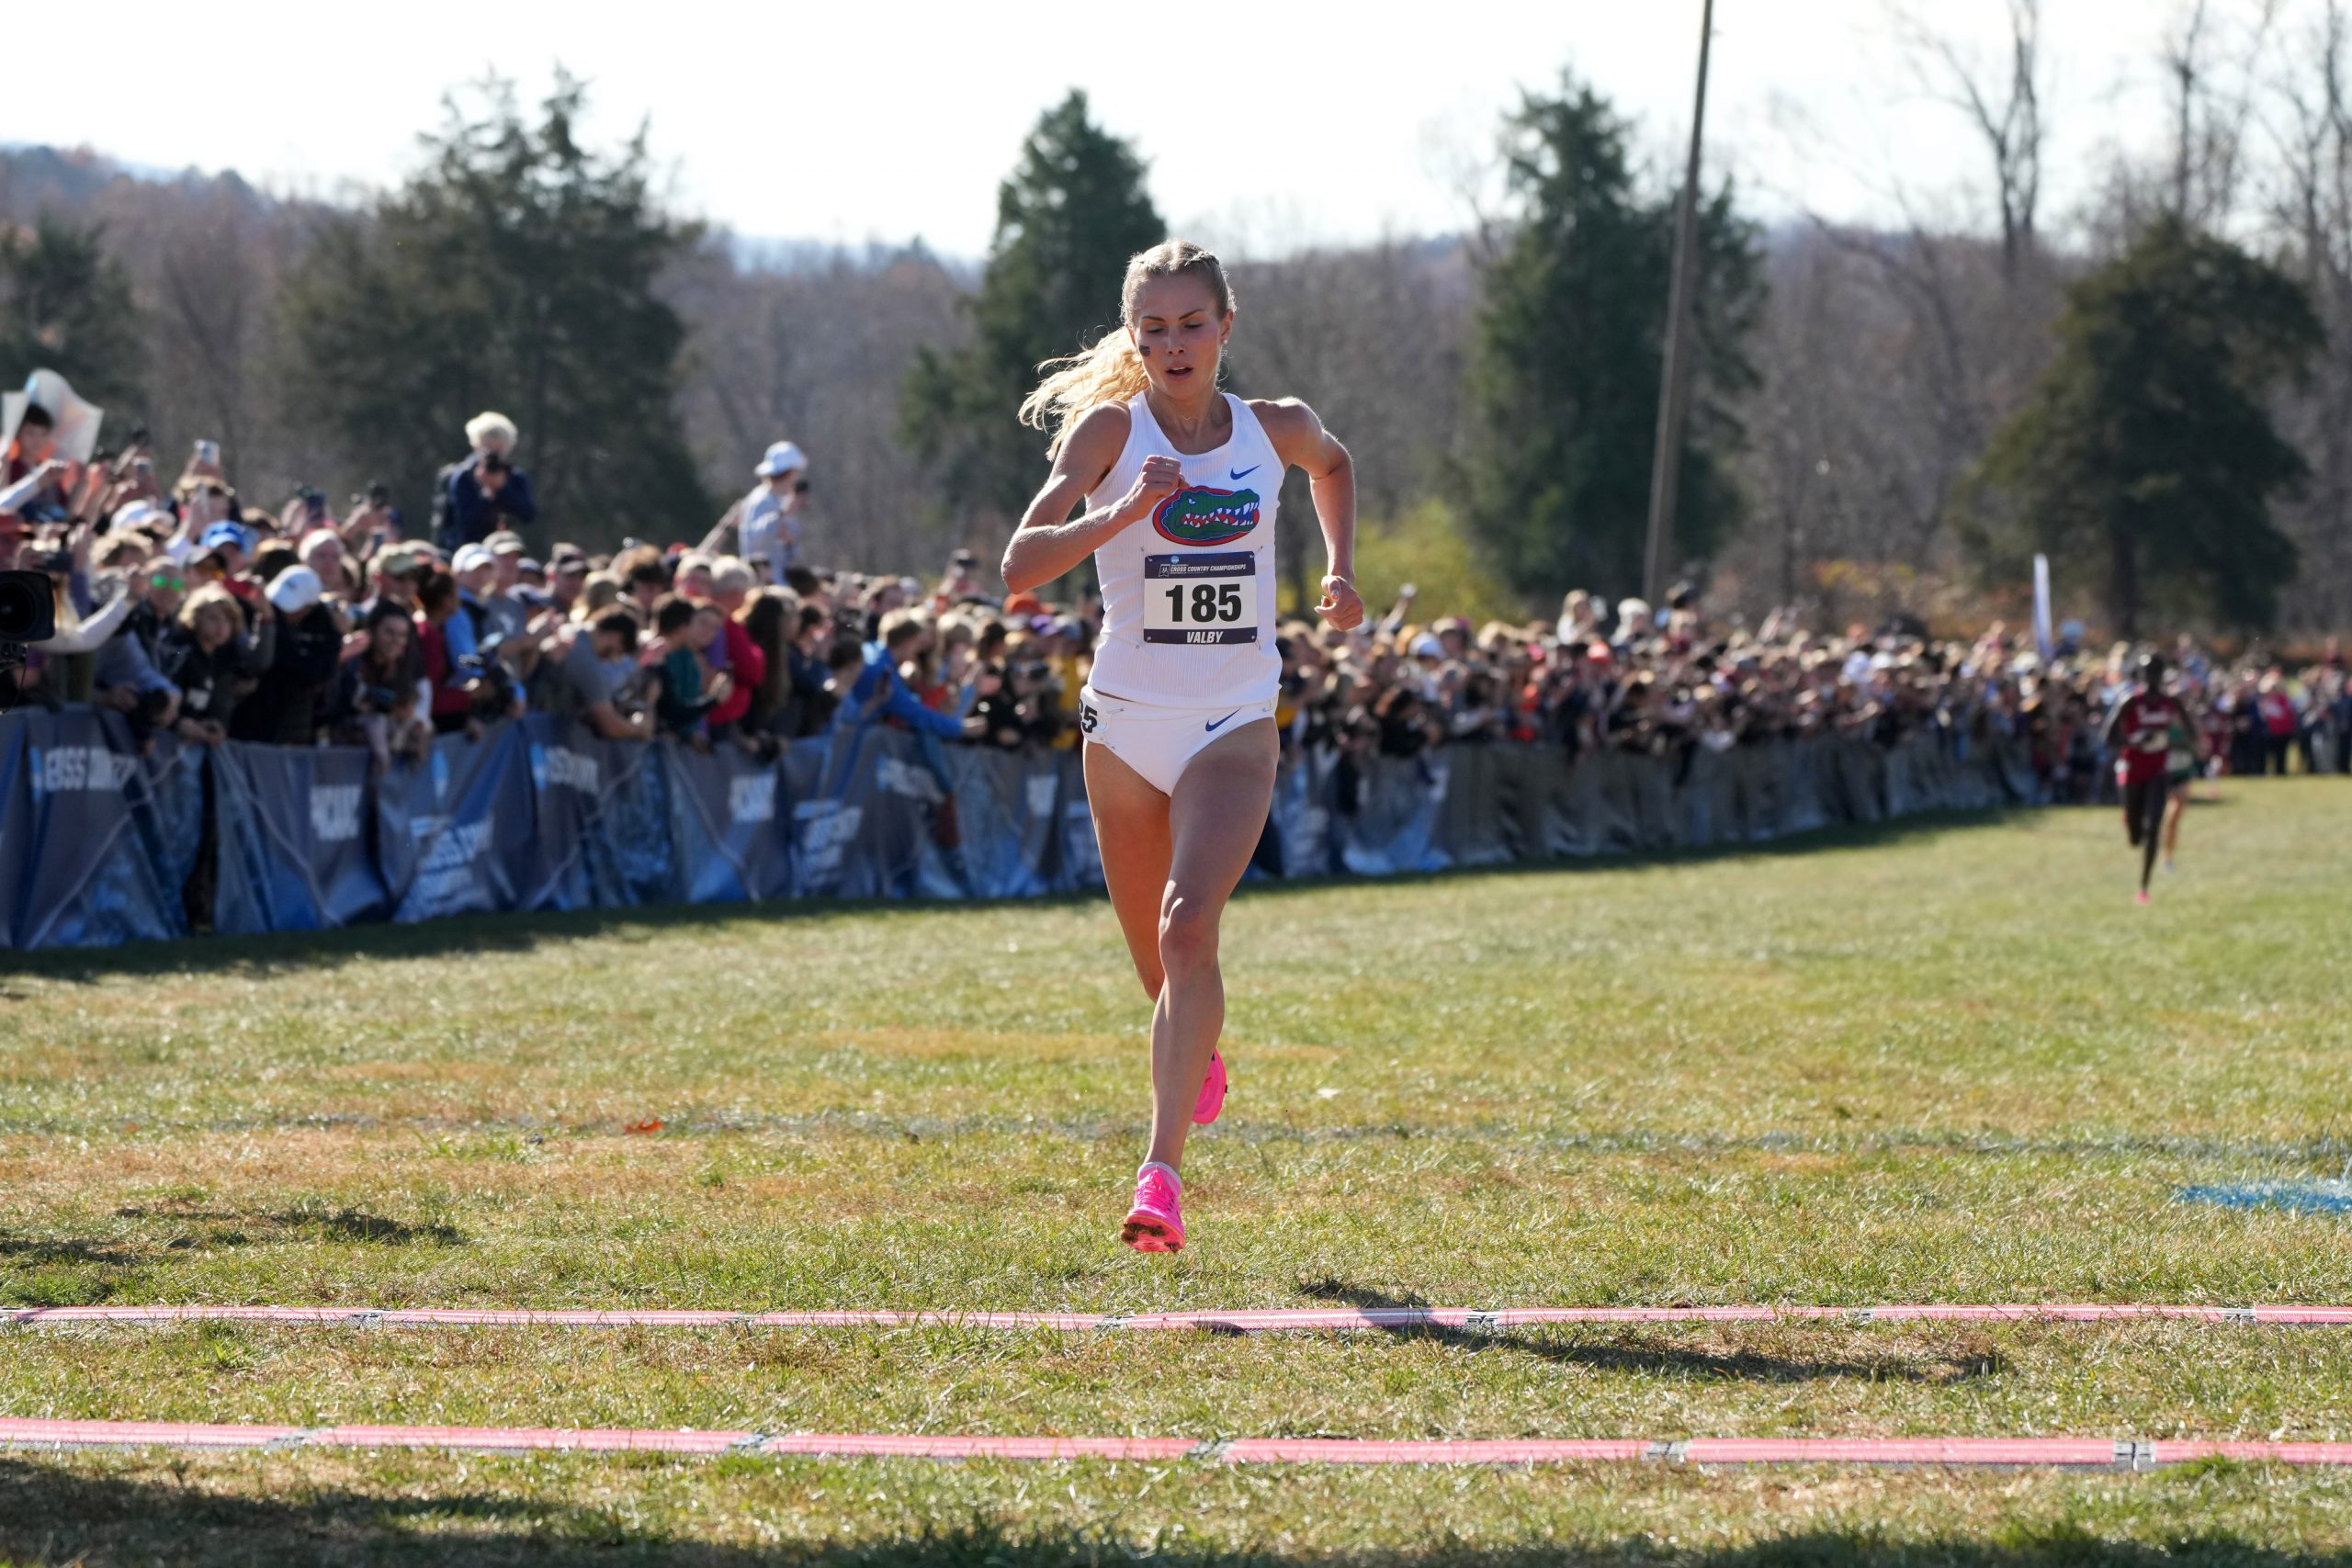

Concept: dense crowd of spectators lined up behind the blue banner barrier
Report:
left=0, top=407, right=2352, bottom=802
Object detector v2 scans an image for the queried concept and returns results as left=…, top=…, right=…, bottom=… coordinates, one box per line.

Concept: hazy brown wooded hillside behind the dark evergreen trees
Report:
left=14, top=122, right=2352, bottom=632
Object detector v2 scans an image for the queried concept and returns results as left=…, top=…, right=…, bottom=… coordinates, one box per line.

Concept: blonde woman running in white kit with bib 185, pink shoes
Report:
left=1004, top=240, right=1364, bottom=1253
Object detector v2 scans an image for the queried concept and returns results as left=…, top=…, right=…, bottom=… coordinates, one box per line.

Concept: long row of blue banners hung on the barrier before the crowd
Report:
left=0, top=707, right=2037, bottom=950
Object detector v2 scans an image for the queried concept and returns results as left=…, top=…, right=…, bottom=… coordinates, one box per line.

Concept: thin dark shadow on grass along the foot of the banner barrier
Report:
left=0, top=807, right=2041, bottom=999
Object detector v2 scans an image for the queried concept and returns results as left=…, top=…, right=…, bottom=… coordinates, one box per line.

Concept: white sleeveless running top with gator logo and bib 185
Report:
left=1087, top=392, right=1282, bottom=710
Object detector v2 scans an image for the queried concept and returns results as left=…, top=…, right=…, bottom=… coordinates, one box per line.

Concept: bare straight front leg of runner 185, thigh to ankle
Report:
left=1148, top=719, right=1280, bottom=1170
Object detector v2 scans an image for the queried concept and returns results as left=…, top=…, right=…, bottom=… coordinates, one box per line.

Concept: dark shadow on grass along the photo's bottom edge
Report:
left=0, top=1460, right=2352, bottom=1568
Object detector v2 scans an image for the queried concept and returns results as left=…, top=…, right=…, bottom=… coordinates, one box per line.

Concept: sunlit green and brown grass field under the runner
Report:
left=0, top=781, right=2352, bottom=1568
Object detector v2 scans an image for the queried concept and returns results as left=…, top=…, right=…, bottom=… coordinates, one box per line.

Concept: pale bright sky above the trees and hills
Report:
left=18, top=0, right=2211, bottom=259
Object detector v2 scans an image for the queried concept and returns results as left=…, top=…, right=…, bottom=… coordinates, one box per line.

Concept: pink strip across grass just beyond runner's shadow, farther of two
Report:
left=0, top=1303, right=2352, bottom=1333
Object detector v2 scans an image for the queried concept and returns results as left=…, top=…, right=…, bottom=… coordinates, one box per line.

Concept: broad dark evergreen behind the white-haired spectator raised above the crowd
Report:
left=285, top=77, right=713, bottom=546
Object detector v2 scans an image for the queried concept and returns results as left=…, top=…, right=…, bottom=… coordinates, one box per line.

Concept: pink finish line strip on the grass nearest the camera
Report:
left=0, top=1417, right=2352, bottom=1472
